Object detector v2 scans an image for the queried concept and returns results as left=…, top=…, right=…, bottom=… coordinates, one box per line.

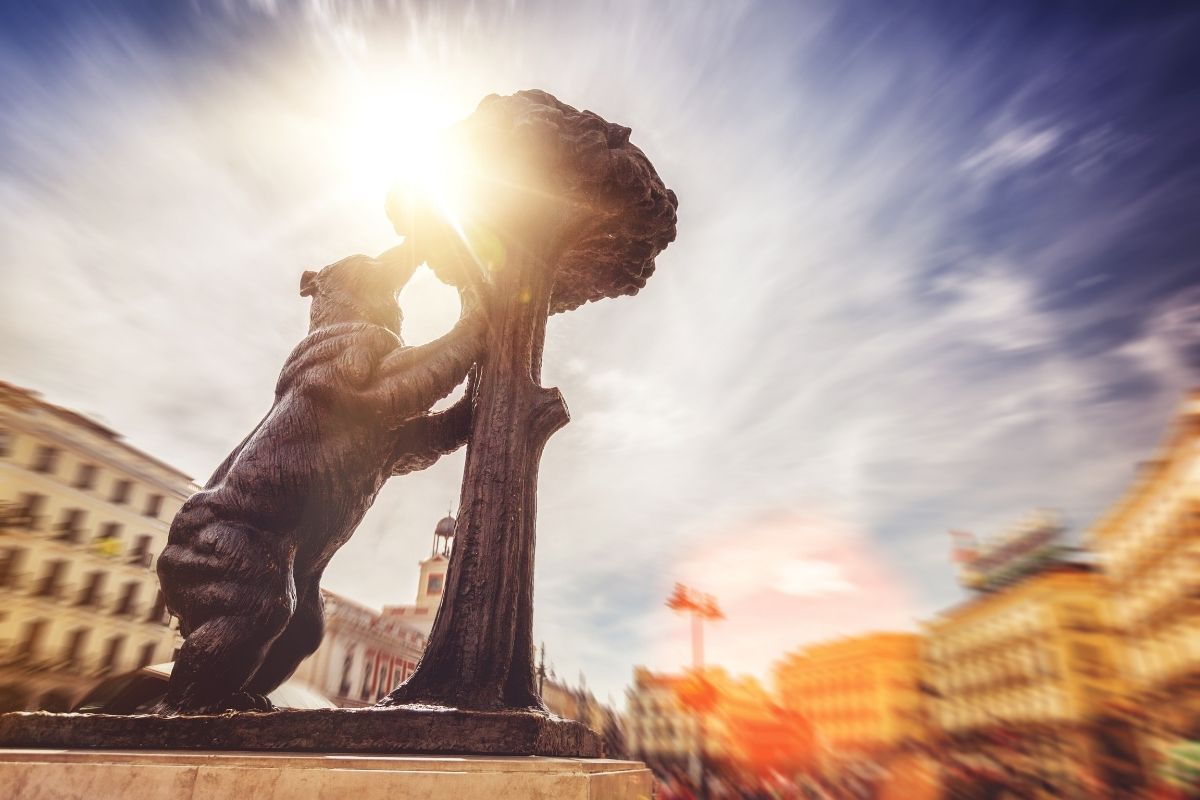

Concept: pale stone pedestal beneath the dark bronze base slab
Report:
left=0, top=750, right=653, bottom=800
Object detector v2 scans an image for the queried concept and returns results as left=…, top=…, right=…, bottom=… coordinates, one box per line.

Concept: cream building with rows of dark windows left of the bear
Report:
left=0, top=383, right=196, bottom=711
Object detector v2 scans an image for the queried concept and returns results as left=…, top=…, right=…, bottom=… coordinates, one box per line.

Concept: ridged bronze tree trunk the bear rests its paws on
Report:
left=384, top=248, right=570, bottom=710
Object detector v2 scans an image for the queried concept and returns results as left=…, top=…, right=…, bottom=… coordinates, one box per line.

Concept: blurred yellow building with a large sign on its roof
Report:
left=924, top=561, right=1123, bottom=774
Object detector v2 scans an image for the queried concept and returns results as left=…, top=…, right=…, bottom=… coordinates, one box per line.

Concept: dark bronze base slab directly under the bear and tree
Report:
left=0, top=709, right=604, bottom=758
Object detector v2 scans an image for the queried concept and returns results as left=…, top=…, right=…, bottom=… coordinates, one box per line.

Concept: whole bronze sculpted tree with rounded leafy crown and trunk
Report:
left=382, top=91, right=677, bottom=710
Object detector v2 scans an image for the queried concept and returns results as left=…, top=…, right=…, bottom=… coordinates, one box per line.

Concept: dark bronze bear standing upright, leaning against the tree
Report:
left=157, top=242, right=487, bottom=714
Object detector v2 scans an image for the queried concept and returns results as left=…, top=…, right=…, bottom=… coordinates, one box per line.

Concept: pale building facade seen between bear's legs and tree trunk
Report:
left=293, top=589, right=425, bottom=708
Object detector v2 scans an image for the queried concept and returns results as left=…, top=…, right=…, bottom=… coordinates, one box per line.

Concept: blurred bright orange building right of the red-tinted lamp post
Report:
left=774, top=633, right=924, bottom=756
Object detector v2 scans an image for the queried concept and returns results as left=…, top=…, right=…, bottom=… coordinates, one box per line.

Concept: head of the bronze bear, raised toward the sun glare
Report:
left=300, top=251, right=416, bottom=336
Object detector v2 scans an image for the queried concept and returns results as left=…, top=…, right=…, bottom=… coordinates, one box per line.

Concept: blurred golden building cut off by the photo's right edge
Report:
left=1088, top=392, right=1200, bottom=752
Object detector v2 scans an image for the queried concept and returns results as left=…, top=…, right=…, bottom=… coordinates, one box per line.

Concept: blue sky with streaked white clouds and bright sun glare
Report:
left=0, top=0, right=1200, bottom=693
